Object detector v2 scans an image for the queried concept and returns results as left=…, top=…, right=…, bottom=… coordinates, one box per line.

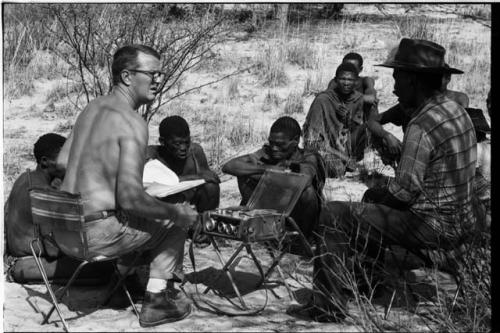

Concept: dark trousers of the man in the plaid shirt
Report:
left=313, top=196, right=451, bottom=311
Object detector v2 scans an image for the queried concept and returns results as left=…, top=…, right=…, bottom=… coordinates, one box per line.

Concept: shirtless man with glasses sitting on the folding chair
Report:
left=54, top=45, right=198, bottom=327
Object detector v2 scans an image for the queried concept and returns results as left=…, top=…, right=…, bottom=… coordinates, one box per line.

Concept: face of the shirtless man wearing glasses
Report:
left=131, top=52, right=162, bottom=104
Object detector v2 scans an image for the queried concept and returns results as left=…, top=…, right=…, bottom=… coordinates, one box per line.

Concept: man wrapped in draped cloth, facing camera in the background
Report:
left=303, top=62, right=380, bottom=178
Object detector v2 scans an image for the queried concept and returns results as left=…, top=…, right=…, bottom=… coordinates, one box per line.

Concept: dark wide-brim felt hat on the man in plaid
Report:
left=375, top=38, right=464, bottom=74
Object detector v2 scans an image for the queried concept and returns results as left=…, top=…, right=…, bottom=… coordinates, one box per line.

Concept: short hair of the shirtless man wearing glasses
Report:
left=111, top=44, right=161, bottom=84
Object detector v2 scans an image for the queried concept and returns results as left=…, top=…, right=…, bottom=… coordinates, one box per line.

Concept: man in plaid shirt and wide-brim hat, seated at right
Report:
left=293, top=38, right=476, bottom=321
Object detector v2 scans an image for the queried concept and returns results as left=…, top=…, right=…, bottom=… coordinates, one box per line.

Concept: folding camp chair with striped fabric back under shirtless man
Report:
left=29, top=188, right=139, bottom=331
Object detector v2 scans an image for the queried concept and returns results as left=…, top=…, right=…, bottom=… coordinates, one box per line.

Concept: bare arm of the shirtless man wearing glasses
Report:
left=116, top=117, right=197, bottom=227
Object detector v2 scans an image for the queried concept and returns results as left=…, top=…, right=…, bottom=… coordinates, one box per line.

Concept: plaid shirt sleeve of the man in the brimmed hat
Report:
left=389, top=124, right=432, bottom=204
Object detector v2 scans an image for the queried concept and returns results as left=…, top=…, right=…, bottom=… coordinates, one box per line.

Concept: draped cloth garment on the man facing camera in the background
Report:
left=303, top=90, right=371, bottom=177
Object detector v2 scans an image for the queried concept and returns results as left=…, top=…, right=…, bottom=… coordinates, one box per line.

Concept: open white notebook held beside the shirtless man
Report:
left=142, top=159, right=205, bottom=198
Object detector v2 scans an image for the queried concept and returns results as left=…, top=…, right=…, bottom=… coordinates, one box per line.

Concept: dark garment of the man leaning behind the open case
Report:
left=237, top=146, right=326, bottom=237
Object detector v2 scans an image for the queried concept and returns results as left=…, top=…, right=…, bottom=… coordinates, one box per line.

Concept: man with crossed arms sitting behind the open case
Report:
left=222, top=116, right=325, bottom=237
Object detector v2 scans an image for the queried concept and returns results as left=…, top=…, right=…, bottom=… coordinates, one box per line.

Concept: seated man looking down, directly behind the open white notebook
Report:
left=146, top=116, right=220, bottom=212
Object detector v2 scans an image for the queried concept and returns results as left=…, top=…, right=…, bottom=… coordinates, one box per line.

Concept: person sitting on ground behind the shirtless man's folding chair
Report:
left=4, top=133, right=112, bottom=283
